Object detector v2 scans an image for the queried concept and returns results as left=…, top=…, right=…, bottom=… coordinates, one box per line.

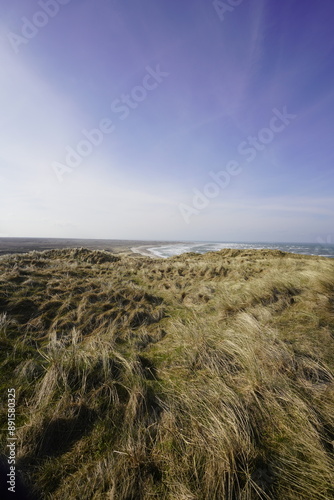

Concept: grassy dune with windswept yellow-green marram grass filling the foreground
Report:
left=0, top=249, right=334, bottom=500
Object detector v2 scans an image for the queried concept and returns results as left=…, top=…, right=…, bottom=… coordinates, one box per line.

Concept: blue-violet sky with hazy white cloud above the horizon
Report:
left=0, top=0, right=334, bottom=242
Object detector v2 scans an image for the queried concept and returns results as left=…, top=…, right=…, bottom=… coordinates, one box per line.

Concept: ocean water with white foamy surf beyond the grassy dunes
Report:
left=148, top=242, right=334, bottom=258
